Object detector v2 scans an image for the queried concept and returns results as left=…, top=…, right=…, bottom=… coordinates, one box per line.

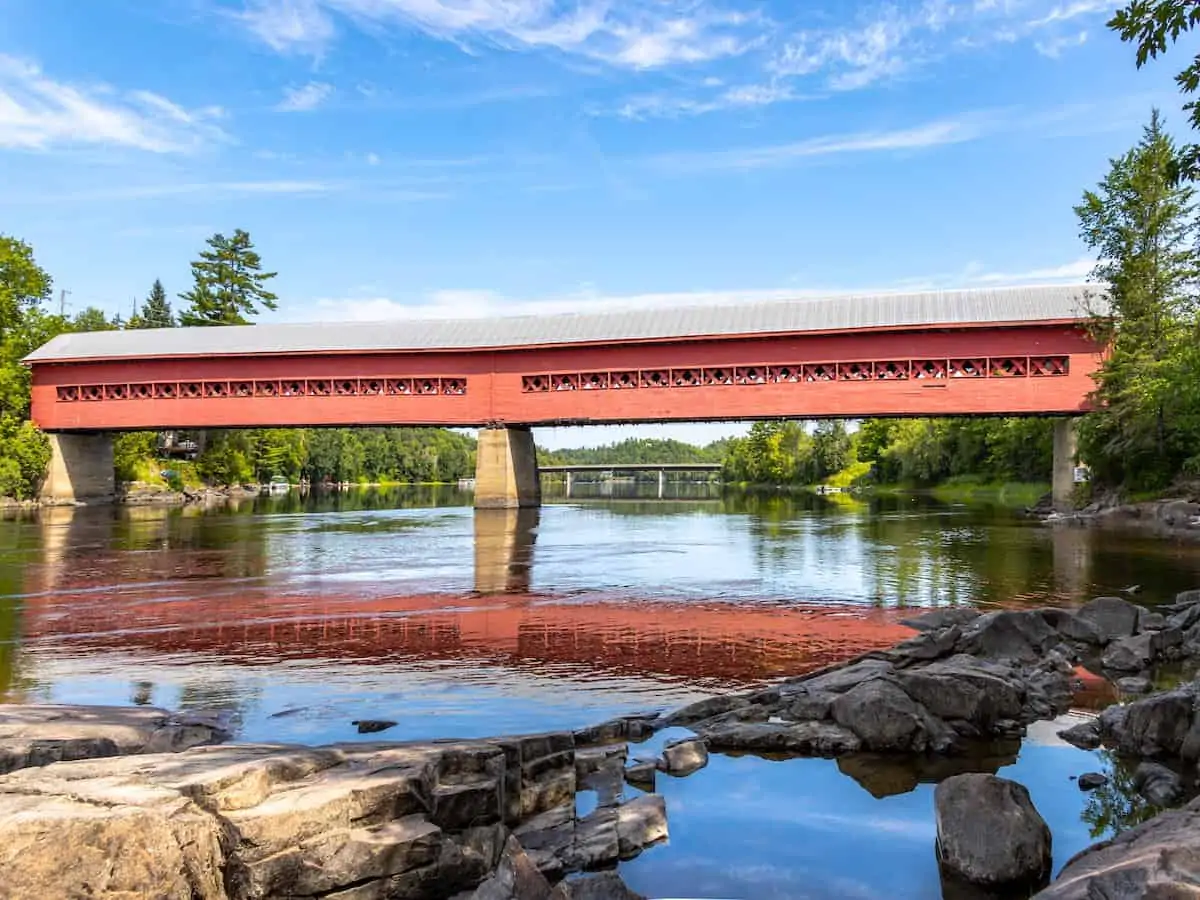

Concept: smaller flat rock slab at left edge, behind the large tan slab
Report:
left=0, top=703, right=229, bottom=775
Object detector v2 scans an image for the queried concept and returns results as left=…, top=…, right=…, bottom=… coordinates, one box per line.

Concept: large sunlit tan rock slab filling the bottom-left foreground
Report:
left=0, top=729, right=648, bottom=900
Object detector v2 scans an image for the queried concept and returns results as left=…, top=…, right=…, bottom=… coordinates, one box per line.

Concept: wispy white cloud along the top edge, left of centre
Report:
left=232, top=0, right=762, bottom=70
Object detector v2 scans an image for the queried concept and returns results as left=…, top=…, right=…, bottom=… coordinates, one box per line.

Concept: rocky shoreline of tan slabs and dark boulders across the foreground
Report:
left=7, top=590, right=1200, bottom=900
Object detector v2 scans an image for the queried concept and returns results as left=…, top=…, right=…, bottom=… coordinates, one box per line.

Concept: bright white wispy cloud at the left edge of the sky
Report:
left=0, top=54, right=227, bottom=154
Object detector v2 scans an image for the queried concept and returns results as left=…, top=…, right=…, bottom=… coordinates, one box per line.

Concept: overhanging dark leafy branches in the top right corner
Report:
left=1109, top=0, right=1200, bottom=180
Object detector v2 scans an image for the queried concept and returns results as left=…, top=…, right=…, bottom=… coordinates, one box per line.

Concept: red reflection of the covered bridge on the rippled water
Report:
left=11, top=509, right=907, bottom=685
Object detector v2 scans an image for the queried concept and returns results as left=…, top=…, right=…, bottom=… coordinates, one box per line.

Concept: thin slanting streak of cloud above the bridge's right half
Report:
left=650, top=115, right=988, bottom=173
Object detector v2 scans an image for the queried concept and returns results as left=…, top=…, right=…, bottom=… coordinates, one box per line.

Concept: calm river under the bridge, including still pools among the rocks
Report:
left=0, top=485, right=1200, bottom=900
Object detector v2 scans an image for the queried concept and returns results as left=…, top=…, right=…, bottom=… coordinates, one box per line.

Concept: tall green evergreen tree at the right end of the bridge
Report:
left=1075, top=112, right=1200, bottom=490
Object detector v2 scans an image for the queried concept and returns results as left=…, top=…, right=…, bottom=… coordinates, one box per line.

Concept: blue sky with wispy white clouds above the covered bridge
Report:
left=0, top=0, right=1186, bottom=446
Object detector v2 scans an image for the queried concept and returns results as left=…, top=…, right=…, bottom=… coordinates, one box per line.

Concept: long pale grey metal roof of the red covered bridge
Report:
left=25, top=284, right=1103, bottom=364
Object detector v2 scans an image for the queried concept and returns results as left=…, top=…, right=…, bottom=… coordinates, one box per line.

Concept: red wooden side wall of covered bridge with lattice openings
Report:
left=32, top=322, right=1099, bottom=431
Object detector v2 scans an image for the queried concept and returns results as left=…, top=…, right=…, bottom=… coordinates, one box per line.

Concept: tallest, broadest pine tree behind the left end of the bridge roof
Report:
left=179, top=228, right=277, bottom=325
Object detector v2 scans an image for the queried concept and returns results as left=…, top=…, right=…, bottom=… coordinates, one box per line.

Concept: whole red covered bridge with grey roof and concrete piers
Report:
left=26, top=286, right=1103, bottom=505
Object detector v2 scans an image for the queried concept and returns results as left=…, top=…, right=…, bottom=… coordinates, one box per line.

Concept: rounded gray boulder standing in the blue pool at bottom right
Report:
left=934, top=774, right=1051, bottom=888
